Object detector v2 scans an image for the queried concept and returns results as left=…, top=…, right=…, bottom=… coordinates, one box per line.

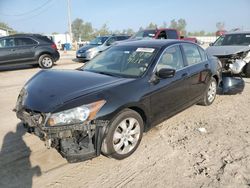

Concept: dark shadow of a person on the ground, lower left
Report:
left=0, top=123, right=41, bottom=188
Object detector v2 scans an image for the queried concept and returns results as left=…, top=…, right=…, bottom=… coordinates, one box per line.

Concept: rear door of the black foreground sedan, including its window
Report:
left=182, top=43, right=211, bottom=100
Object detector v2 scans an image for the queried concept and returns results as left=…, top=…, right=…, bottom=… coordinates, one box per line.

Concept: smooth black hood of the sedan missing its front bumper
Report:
left=23, top=70, right=130, bottom=113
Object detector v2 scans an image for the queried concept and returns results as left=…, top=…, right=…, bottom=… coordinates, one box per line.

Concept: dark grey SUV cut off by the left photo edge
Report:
left=0, top=34, right=60, bottom=68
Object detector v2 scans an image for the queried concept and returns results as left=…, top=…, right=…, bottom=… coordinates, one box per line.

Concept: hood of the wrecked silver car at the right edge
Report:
left=206, top=46, right=250, bottom=56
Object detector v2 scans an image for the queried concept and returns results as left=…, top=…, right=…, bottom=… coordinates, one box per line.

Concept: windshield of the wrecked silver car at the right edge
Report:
left=214, top=33, right=250, bottom=46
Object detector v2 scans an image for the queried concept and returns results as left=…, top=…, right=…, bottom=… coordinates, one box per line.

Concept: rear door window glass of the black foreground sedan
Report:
left=182, top=44, right=202, bottom=65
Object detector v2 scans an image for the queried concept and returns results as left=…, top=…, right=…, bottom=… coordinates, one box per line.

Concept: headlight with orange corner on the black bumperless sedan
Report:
left=47, top=100, right=106, bottom=126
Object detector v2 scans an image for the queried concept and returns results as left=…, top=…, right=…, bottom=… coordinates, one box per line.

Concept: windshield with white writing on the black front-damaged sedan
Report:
left=83, top=46, right=157, bottom=77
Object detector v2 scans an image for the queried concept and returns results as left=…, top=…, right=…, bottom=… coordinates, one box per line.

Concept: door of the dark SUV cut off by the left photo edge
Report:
left=0, top=38, right=15, bottom=65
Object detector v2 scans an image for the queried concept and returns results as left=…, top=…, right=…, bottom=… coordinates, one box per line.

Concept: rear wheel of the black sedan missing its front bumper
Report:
left=199, top=77, right=217, bottom=106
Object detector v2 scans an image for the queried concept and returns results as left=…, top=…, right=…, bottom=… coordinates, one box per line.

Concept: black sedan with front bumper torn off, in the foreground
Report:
left=15, top=40, right=220, bottom=162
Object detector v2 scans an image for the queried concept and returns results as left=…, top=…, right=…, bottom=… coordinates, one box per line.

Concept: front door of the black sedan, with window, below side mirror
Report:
left=150, top=45, right=188, bottom=122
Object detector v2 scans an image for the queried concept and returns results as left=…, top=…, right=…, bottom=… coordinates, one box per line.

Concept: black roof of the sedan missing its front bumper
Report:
left=116, top=39, right=189, bottom=48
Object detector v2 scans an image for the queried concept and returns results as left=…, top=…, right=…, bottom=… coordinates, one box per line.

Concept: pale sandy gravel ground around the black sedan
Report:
left=0, top=56, right=250, bottom=188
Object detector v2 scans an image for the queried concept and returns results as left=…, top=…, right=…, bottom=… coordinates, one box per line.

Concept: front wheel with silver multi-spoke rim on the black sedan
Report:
left=102, top=109, right=144, bottom=160
